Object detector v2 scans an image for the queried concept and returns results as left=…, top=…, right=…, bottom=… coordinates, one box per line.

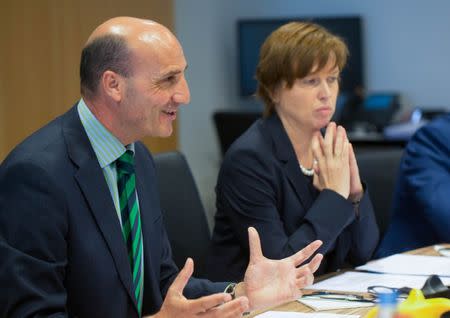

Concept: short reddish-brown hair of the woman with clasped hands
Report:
left=256, top=22, right=348, bottom=117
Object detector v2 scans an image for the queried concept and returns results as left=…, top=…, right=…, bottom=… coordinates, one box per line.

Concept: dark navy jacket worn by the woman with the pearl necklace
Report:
left=208, top=114, right=378, bottom=280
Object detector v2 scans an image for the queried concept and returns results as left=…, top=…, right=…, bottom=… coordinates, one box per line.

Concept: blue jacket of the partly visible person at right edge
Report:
left=377, top=115, right=450, bottom=257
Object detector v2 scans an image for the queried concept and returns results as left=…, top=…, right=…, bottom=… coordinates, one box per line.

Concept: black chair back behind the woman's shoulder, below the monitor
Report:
left=213, top=111, right=262, bottom=156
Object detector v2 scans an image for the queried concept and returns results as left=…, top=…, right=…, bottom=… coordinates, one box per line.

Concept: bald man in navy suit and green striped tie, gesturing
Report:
left=0, top=17, right=322, bottom=318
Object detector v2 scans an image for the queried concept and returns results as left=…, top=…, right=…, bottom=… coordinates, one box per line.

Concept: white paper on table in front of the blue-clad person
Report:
left=356, top=254, right=450, bottom=276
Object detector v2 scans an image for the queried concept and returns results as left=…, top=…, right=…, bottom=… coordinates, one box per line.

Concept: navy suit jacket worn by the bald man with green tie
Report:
left=0, top=107, right=226, bottom=318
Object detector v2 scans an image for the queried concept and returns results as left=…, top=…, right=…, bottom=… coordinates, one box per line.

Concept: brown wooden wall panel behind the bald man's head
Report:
left=0, top=0, right=178, bottom=161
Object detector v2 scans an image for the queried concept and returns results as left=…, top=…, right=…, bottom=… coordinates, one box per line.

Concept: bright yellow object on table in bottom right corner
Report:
left=365, top=289, right=450, bottom=318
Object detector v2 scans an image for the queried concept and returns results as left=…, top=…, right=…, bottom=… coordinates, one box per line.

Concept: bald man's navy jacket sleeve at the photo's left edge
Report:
left=0, top=162, right=68, bottom=317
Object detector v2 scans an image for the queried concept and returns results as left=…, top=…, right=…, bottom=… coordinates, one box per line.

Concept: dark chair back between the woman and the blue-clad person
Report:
left=356, top=148, right=403, bottom=239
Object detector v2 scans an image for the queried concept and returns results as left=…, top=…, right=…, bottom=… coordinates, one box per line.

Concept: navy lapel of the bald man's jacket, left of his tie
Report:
left=63, top=106, right=137, bottom=308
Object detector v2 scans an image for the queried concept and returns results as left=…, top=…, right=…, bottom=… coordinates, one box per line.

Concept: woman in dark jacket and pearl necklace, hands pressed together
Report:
left=208, top=22, right=379, bottom=280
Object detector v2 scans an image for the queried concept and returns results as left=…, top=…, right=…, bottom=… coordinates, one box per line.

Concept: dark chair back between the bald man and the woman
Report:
left=154, top=152, right=211, bottom=277
